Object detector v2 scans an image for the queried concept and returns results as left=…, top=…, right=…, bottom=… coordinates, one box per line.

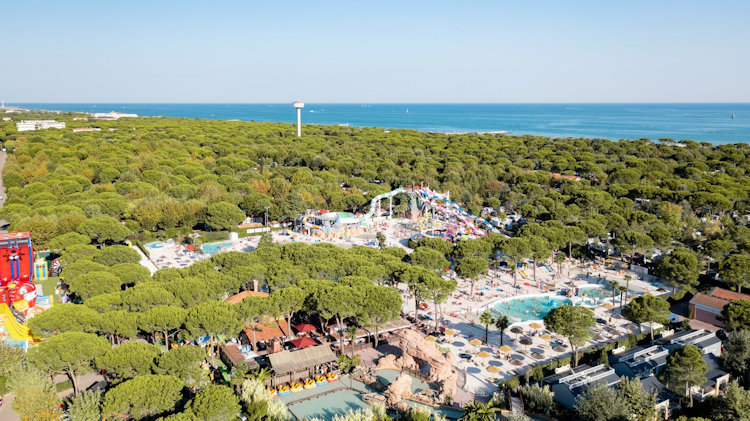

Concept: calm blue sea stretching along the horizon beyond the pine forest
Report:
left=8, top=103, right=750, bottom=144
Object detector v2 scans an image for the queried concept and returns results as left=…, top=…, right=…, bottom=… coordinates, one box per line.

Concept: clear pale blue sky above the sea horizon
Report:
left=0, top=0, right=750, bottom=103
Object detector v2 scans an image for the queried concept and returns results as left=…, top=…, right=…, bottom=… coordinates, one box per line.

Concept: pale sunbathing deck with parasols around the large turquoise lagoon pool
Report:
left=399, top=261, right=669, bottom=398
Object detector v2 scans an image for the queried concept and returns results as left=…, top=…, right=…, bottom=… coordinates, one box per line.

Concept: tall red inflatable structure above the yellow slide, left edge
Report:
left=0, top=231, right=34, bottom=287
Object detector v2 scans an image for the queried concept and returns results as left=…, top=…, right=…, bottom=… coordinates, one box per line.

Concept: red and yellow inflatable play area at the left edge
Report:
left=0, top=231, right=53, bottom=349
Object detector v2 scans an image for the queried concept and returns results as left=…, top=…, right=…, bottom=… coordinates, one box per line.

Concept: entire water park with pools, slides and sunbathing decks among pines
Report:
left=126, top=186, right=680, bottom=419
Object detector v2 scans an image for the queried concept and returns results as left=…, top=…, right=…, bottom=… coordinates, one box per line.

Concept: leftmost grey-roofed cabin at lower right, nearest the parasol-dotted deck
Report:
left=542, top=364, right=620, bottom=410
